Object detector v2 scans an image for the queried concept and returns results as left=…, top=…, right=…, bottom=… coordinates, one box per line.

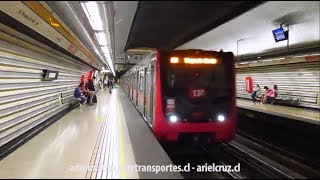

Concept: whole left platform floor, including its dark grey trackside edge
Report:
left=0, top=89, right=182, bottom=179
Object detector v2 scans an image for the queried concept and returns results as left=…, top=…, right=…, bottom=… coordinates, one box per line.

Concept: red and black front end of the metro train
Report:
left=154, top=50, right=236, bottom=144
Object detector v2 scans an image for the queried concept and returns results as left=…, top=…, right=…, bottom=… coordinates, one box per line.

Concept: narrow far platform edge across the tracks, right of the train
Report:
left=236, top=98, right=320, bottom=125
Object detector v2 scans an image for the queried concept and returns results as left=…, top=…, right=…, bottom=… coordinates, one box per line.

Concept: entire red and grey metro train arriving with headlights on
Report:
left=120, top=50, right=237, bottom=144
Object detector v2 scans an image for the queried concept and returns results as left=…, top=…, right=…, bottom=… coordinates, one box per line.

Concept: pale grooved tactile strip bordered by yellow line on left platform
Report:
left=85, top=90, right=139, bottom=179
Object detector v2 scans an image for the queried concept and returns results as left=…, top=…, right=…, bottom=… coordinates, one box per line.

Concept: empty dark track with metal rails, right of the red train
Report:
left=219, top=133, right=320, bottom=179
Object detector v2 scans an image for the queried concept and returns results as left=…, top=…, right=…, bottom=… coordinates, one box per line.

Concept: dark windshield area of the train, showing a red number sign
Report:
left=162, top=53, right=234, bottom=122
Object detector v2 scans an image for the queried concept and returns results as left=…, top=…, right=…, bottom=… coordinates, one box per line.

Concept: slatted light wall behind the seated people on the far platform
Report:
left=236, top=61, right=320, bottom=109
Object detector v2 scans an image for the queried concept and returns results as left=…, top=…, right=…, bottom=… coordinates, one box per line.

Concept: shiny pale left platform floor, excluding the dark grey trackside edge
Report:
left=0, top=89, right=139, bottom=179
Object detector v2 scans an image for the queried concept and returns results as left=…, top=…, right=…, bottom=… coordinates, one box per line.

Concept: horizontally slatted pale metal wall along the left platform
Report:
left=0, top=35, right=92, bottom=147
